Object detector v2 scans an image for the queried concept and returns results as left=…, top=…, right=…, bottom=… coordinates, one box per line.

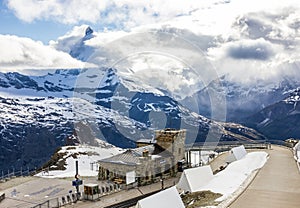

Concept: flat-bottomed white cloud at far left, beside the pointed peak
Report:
left=0, top=35, right=92, bottom=71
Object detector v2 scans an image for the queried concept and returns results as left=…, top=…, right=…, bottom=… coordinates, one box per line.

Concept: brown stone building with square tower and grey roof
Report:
left=99, top=129, right=186, bottom=185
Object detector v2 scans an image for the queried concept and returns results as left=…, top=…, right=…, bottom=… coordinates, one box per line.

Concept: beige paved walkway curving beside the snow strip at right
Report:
left=230, top=146, right=300, bottom=208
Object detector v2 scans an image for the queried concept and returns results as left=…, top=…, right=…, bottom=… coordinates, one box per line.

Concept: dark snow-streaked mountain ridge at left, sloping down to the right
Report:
left=0, top=68, right=264, bottom=172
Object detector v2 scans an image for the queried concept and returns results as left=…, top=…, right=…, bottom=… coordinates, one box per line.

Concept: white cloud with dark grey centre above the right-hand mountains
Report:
left=208, top=38, right=300, bottom=84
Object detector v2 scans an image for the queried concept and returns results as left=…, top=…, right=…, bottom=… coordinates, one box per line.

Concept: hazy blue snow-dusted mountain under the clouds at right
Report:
left=182, top=76, right=300, bottom=122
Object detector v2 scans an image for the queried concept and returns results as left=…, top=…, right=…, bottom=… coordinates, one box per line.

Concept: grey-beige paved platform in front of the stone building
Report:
left=0, top=174, right=180, bottom=208
